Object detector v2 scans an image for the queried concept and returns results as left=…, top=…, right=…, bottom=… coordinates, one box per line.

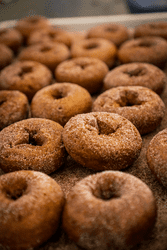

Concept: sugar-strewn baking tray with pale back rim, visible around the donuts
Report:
left=0, top=13, right=167, bottom=250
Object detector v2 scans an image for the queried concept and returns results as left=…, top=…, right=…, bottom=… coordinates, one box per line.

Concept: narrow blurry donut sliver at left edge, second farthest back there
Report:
left=0, top=43, right=14, bottom=70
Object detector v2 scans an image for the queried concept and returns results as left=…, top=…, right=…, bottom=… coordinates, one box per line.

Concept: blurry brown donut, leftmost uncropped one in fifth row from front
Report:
left=18, top=42, right=70, bottom=71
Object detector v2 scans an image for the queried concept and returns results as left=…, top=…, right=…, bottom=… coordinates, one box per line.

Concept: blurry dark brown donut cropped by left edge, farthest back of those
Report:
left=0, top=28, right=23, bottom=52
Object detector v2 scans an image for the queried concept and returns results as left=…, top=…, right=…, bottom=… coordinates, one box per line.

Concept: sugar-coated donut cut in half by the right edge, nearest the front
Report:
left=146, top=128, right=167, bottom=187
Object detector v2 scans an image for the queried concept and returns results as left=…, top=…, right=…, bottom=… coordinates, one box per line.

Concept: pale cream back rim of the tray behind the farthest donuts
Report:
left=0, top=12, right=167, bottom=31
